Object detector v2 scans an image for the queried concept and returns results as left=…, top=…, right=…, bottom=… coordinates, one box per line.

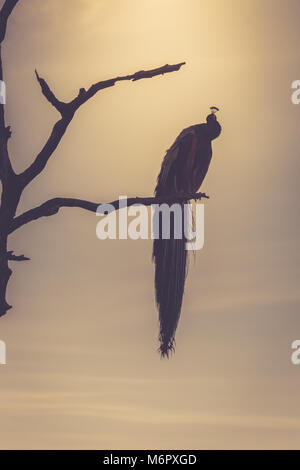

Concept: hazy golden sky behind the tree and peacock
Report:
left=0, top=0, right=300, bottom=449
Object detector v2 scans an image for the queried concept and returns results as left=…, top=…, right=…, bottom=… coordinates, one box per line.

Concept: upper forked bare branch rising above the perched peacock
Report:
left=20, top=62, right=185, bottom=186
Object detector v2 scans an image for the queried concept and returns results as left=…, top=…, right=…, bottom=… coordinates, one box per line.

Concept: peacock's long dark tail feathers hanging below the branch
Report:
left=153, top=203, right=187, bottom=357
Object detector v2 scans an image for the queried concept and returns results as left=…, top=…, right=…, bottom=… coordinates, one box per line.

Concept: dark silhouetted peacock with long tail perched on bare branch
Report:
left=153, top=106, right=222, bottom=357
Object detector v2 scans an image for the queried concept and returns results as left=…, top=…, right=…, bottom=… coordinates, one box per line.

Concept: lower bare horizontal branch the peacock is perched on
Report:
left=9, top=193, right=209, bottom=233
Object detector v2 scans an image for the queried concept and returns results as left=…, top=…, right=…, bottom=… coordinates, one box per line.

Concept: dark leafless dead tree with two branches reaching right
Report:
left=0, top=0, right=206, bottom=316
